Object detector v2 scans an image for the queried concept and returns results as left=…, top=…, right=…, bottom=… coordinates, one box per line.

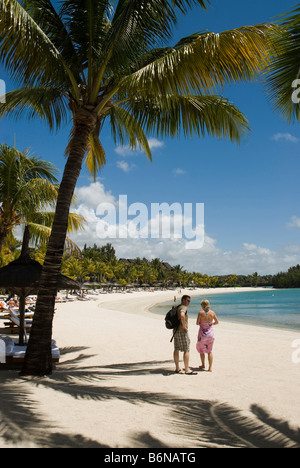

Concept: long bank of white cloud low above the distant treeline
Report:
left=71, top=182, right=300, bottom=275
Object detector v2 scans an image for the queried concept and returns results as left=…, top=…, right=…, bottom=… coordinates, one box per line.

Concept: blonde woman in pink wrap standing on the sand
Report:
left=196, top=299, right=219, bottom=372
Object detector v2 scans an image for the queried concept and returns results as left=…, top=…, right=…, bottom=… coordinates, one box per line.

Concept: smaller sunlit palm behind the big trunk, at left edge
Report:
left=0, top=144, right=85, bottom=258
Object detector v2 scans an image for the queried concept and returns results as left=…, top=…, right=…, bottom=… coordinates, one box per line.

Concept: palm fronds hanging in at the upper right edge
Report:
left=265, top=4, right=300, bottom=123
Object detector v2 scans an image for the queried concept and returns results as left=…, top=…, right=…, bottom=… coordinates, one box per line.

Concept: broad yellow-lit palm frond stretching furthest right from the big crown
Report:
left=120, top=24, right=273, bottom=96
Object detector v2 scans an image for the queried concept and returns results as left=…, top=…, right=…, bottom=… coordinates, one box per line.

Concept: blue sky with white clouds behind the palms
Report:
left=0, top=0, right=300, bottom=274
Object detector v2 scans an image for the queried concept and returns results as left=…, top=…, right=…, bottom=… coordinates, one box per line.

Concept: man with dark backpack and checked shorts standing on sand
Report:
left=173, top=295, right=196, bottom=375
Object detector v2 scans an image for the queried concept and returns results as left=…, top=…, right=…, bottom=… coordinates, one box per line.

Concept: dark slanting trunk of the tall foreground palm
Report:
left=21, top=111, right=96, bottom=376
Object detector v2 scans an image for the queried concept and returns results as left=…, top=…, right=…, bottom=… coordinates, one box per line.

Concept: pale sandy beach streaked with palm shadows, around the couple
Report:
left=0, top=288, right=300, bottom=449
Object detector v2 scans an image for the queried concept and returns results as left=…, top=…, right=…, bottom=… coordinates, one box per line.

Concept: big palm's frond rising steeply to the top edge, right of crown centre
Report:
left=92, top=0, right=209, bottom=100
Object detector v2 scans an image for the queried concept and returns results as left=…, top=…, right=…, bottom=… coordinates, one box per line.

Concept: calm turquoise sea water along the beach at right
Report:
left=151, top=289, right=300, bottom=330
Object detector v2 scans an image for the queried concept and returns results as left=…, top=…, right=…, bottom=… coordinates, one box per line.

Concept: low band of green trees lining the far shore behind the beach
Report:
left=0, top=240, right=274, bottom=288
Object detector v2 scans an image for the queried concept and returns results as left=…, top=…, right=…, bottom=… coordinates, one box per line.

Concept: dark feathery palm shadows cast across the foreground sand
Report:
left=0, top=348, right=300, bottom=448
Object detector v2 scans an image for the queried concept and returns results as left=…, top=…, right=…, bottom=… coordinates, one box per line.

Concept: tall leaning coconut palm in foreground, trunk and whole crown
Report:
left=0, top=0, right=274, bottom=375
